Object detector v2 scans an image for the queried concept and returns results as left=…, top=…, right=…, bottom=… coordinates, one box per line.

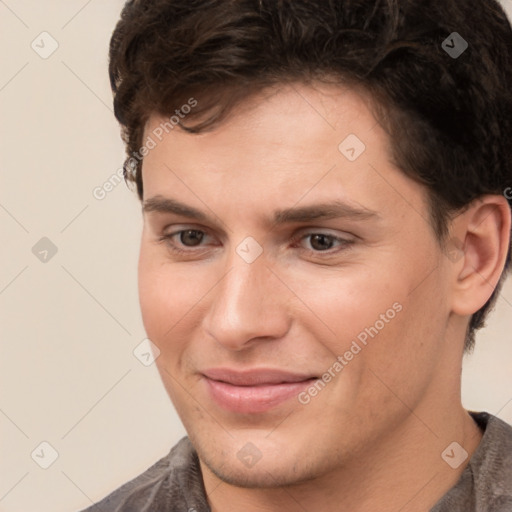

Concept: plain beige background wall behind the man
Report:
left=0, top=0, right=512, bottom=512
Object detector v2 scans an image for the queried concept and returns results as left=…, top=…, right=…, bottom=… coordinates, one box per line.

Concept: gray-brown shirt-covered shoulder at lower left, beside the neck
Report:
left=77, top=437, right=208, bottom=512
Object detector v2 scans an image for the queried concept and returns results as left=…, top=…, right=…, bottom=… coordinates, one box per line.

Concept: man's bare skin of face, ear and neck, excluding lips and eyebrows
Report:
left=139, top=84, right=510, bottom=512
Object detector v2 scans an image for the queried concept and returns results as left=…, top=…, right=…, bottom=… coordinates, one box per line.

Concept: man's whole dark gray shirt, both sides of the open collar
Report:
left=83, top=412, right=512, bottom=512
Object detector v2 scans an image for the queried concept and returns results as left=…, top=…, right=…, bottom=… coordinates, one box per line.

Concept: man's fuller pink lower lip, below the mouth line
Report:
left=205, top=378, right=316, bottom=414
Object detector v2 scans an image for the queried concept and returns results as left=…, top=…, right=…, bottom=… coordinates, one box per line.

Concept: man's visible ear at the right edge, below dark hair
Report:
left=449, top=195, right=511, bottom=316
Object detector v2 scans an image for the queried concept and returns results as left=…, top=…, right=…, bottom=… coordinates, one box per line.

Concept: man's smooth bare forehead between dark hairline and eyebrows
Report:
left=139, top=84, right=424, bottom=224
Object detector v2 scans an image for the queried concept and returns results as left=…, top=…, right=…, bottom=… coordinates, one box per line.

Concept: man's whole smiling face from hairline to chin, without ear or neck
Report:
left=139, top=84, right=449, bottom=487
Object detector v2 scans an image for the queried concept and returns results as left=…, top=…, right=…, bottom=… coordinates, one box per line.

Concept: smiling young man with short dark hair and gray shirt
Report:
left=83, top=0, right=512, bottom=512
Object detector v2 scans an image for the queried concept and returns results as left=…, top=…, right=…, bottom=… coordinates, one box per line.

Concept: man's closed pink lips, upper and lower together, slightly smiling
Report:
left=203, top=368, right=317, bottom=414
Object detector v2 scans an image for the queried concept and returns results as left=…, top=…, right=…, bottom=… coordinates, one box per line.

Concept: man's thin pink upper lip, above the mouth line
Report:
left=202, top=368, right=316, bottom=386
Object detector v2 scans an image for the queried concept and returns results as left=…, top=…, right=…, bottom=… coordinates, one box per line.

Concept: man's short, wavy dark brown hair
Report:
left=109, top=0, right=512, bottom=351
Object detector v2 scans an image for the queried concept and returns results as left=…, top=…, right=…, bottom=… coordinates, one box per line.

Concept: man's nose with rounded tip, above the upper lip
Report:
left=203, top=254, right=290, bottom=351
